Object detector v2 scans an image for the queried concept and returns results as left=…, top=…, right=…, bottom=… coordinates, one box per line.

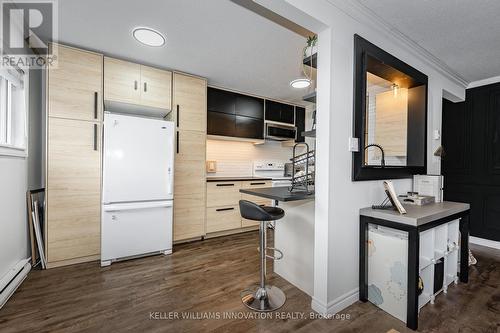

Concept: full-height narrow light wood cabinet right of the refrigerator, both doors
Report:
left=173, top=73, right=207, bottom=241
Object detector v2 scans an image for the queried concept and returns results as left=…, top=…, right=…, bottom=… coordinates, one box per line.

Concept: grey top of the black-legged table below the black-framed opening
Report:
left=359, top=201, right=470, bottom=227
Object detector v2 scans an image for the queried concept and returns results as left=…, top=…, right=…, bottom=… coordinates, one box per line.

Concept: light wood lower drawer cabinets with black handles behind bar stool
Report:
left=206, top=180, right=272, bottom=234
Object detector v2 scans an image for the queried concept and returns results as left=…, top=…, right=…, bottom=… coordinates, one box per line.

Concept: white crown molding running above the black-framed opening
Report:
left=327, top=0, right=469, bottom=88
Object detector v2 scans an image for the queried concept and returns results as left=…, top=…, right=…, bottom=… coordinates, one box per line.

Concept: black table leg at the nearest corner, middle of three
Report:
left=406, top=228, right=420, bottom=330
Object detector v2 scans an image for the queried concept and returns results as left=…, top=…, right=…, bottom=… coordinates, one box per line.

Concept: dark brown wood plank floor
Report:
left=0, top=233, right=500, bottom=333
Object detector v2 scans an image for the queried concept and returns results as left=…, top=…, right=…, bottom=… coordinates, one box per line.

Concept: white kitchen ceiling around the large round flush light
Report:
left=49, top=0, right=308, bottom=102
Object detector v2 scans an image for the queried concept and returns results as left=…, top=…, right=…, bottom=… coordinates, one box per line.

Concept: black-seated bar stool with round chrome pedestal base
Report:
left=240, top=200, right=286, bottom=312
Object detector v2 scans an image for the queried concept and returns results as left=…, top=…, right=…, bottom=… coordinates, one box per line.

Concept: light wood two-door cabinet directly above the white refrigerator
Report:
left=104, top=57, right=172, bottom=110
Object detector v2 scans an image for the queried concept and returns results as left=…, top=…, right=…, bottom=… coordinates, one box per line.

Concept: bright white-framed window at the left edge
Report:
left=0, top=69, right=27, bottom=156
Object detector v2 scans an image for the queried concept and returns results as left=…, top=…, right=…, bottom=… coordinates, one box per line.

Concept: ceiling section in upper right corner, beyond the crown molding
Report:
left=357, top=0, right=500, bottom=82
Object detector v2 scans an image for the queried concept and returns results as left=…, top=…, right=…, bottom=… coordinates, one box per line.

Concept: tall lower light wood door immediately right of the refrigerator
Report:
left=174, top=131, right=206, bottom=241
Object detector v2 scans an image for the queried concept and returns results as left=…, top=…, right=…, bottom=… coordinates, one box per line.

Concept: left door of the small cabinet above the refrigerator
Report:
left=104, top=57, right=141, bottom=104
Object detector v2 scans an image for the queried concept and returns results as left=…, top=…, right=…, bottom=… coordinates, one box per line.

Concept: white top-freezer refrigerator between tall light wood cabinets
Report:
left=101, top=113, right=174, bottom=266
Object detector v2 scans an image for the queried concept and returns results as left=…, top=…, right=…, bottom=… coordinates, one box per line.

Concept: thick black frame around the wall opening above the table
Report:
left=352, top=35, right=429, bottom=181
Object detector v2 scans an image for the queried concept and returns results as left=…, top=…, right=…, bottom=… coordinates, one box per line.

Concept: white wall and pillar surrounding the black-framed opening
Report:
left=264, top=0, right=465, bottom=312
